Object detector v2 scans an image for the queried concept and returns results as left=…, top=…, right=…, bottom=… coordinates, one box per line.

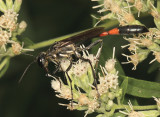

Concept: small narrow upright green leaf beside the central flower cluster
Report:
left=120, top=78, right=128, bottom=104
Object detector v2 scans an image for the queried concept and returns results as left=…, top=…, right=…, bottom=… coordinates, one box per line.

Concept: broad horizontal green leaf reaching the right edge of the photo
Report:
left=120, top=76, right=160, bottom=98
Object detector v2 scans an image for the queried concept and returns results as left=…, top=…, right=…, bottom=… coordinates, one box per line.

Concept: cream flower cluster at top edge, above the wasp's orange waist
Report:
left=92, top=0, right=140, bottom=26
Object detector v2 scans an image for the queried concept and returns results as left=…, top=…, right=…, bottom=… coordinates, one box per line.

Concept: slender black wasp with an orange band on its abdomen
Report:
left=19, top=25, right=148, bottom=104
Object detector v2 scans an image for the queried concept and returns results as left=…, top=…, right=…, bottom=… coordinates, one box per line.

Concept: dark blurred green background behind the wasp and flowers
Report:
left=0, top=0, right=158, bottom=117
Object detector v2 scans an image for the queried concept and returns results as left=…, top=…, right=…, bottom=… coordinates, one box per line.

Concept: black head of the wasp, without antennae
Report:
left=37, top=52, right=48, bottom=68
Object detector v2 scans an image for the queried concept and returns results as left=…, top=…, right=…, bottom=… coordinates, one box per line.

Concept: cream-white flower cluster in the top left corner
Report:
left=0, top=0, right=33, bottom=56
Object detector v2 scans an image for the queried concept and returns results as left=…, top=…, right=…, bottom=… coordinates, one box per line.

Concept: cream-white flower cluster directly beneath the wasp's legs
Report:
left=51, top=47, right=118, bottom=117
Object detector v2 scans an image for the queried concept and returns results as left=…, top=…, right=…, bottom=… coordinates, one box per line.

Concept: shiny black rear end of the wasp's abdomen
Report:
left=118, top=25, right=149, bottom=35
